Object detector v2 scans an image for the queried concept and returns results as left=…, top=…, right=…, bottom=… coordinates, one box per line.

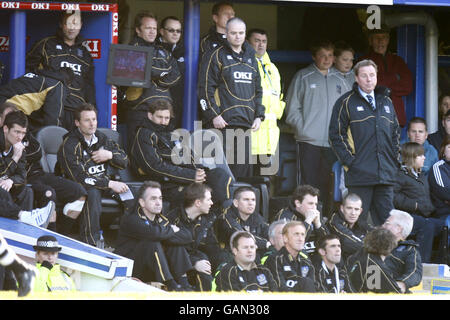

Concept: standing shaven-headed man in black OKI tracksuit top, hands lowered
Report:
left=198, top=18, right=265, bottom=179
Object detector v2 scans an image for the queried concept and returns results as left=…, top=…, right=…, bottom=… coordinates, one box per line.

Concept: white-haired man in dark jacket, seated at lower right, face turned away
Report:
left=383, top=209, right=422, bottom=293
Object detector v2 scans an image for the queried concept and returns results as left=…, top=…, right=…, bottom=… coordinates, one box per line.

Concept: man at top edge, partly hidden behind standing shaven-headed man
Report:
left=200, top=1, right=234, bottom=60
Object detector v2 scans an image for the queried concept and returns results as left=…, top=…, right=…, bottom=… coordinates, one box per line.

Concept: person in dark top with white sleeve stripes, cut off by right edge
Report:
left=428, top=134, right=450, bottom=220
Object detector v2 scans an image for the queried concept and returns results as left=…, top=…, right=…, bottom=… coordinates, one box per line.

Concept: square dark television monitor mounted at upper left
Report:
left=106, top=44, right=154, bottom=88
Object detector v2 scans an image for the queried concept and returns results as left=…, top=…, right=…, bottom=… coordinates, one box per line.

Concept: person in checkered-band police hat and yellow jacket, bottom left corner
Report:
left=33, top=235, right=76, bottom=292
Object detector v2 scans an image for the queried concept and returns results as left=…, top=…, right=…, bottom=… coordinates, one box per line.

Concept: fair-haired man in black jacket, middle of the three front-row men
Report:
left=266, top=221, right=316, bottom=292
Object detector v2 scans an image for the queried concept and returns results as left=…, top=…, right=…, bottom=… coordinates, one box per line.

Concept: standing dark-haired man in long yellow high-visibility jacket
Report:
left=247, top=29, right=285, bottom=175
